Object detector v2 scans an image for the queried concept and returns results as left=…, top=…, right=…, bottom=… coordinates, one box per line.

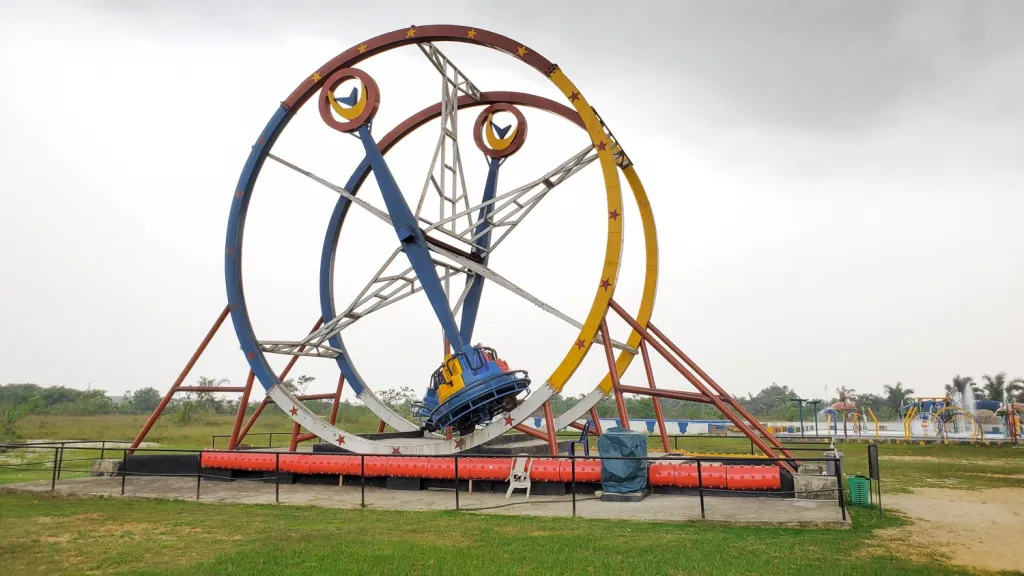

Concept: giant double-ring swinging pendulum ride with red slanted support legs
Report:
left=132, top=25, right=793, bottom=469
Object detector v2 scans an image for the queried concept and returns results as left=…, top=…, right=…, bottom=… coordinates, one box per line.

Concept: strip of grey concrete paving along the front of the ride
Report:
left=3, top=478, right=850, bottom=528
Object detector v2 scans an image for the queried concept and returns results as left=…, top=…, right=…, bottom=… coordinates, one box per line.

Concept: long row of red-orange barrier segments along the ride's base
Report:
left=195, top=452, right=782, bottom=491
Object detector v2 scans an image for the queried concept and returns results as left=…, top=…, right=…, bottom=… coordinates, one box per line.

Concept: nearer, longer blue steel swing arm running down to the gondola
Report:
left=358, top=124, right=464, bottom=353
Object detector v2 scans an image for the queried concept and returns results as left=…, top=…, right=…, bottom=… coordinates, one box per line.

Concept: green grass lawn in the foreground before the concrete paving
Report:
left=0, top=493, right=991, bottom=576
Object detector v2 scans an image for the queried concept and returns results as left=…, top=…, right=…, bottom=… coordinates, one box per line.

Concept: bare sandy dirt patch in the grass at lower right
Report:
left=881, top=488, right=1024, bottom=571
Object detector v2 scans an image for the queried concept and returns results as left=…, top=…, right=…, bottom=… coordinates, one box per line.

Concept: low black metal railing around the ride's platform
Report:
left=0, top=433, right=847, bottom=522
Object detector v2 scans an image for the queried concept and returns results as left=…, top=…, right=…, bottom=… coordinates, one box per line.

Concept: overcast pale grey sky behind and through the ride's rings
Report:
left=0, top=0, right=1024, bottom=403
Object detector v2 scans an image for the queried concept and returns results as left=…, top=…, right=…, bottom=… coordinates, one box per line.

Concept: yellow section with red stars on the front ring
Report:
left=548, top=69, right=625, bottom=392
